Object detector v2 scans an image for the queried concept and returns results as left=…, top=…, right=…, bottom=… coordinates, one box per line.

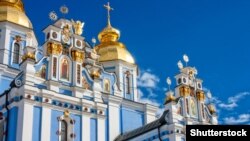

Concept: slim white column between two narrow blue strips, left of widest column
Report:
left=97, top=117, right=106, bottom=141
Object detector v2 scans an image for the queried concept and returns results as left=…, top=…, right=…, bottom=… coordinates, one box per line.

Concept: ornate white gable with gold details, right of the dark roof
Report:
left=165, top=55, right=217, bottom=125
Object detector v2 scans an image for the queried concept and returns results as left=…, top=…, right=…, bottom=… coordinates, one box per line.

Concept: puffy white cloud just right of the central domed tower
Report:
left=137, top=70, right=160, bottom=88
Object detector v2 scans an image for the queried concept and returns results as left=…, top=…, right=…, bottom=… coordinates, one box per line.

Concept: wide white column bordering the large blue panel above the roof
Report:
left=108, top=103, right=120, bottom=141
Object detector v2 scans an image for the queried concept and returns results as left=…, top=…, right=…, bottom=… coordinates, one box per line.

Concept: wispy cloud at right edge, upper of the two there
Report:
left=218, top=92, right=250, bottom=110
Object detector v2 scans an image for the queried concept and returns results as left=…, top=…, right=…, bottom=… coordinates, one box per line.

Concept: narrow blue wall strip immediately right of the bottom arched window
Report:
left=71, top=114, right=82, bottom=141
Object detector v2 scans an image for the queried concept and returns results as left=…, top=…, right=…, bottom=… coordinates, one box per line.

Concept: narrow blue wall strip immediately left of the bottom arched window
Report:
left=50, top=110, right=63, bottom=141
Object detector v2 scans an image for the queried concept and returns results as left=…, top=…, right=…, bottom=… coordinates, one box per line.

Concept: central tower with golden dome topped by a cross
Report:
left=95, top=3, right=138, bottom=101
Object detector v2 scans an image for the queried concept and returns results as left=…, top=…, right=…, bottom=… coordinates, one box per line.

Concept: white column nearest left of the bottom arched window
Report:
left=41, top=106, right=51, bottom=141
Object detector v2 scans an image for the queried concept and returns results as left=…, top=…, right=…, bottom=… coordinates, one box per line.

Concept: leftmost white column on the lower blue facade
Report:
left=17, top=103, right=33, bottom=141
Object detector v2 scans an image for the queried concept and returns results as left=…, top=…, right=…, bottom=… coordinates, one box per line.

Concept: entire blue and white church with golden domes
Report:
left=0, top=0, right=217, bottom=141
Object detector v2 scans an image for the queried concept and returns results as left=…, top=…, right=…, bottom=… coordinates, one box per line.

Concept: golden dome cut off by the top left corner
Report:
left=0, top=0, right=32, bottom=28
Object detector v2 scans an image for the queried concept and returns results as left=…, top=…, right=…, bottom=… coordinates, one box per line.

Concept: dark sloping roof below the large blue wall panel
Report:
left=115, top=110, right=169, bottom=141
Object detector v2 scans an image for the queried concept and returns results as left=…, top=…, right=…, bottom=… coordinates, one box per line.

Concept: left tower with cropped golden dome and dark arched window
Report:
left=0, top=0, right=38, bottom=69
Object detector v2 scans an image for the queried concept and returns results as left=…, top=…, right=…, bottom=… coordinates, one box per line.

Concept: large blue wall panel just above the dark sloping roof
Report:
left=120, top=107, right=144, bottom=133
